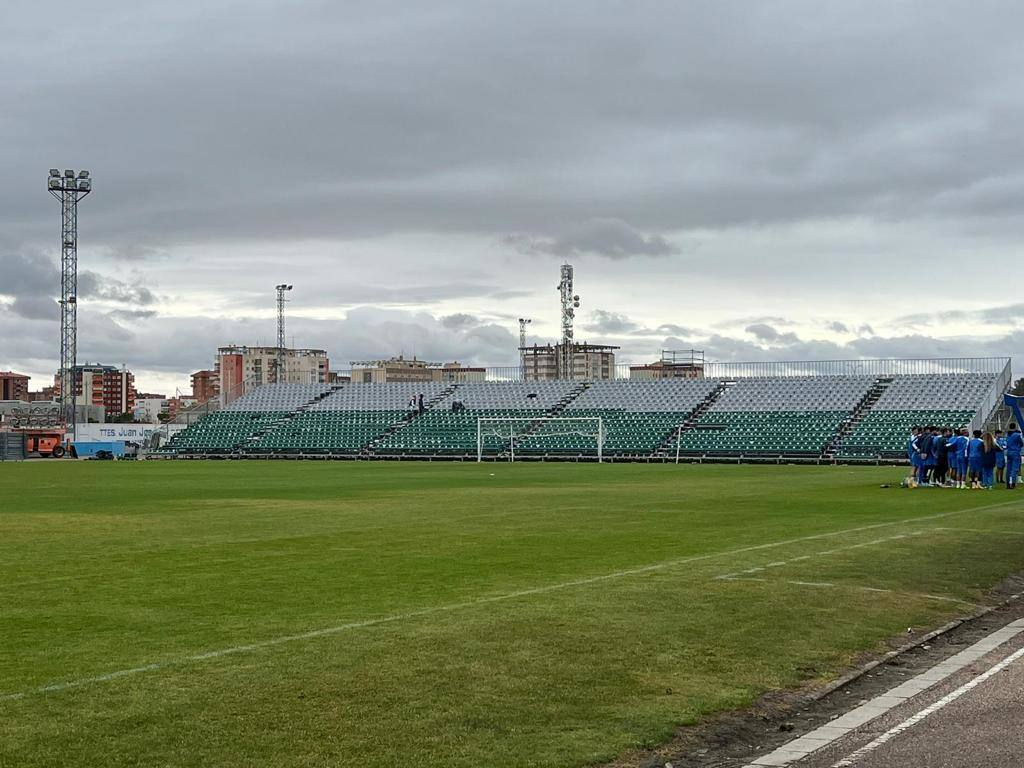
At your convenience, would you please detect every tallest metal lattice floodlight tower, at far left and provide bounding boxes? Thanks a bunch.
[46,168,92,440]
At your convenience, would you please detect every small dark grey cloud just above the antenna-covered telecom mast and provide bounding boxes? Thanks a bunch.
[502,218,679,259]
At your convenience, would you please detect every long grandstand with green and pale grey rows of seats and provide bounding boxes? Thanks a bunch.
[155,358,1011,462]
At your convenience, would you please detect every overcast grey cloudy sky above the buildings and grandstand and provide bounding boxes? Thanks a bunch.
[0,0,1024,392]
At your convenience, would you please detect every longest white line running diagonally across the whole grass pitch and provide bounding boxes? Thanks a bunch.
[0,501,1019,701]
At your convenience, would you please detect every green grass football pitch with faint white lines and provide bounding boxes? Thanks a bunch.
[6,462,1024,767]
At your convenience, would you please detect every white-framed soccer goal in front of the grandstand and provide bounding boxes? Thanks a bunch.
[476,416,604,462]
